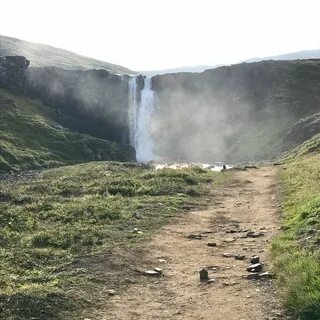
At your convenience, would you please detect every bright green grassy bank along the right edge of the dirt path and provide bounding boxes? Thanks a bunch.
[271,136,320,320]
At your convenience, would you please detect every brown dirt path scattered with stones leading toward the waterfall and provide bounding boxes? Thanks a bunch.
[103,167,282,320]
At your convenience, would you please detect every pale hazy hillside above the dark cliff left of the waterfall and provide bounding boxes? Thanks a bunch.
[0,35,135,74]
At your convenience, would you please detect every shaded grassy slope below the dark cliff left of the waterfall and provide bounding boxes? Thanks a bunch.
[0,90,132,171]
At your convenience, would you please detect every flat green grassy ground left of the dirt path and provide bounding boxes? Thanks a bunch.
[0,162,228,320]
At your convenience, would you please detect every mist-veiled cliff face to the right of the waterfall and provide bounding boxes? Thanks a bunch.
[153,60,320,162]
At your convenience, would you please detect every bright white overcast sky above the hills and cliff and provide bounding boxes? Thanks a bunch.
[0,0,320,71]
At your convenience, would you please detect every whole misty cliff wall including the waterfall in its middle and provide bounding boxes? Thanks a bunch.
[0,50,320,170]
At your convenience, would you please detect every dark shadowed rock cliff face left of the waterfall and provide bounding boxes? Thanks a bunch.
[0,57,139,144]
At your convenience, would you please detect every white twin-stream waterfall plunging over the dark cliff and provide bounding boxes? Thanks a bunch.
[129,77,155,162]
